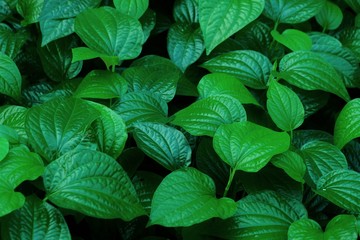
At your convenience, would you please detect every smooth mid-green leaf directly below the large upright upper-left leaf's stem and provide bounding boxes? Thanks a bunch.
[74,70,128,99]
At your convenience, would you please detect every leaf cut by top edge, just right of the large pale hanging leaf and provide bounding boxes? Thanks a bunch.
[263,0,326,24]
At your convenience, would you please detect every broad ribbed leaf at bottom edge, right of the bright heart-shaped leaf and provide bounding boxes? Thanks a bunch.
[212,191,307,240]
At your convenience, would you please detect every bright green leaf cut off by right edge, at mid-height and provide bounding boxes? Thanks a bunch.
[334,98,360,149]
